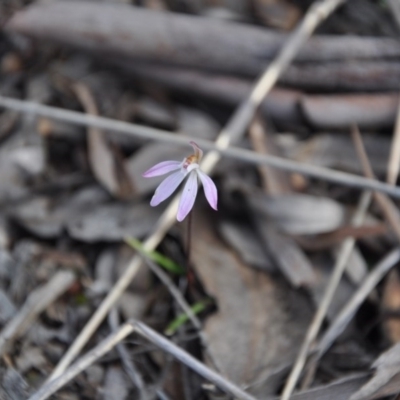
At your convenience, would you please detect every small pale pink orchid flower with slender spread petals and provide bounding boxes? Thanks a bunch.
[143,142,218,222]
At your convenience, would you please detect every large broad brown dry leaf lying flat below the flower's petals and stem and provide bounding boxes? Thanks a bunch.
[192,209,311,397]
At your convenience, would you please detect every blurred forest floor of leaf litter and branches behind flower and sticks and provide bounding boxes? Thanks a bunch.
[0,0,400,400]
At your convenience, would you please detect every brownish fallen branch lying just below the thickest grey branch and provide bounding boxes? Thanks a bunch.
[124,60,399,130]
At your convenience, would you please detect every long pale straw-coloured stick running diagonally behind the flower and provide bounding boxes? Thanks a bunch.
[46,0,346,379]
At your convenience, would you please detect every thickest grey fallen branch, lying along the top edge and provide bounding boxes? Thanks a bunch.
[6,1,400,76]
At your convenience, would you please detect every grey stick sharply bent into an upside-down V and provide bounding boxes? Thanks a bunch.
[29,321,256,400]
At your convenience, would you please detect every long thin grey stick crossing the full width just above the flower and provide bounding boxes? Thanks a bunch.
[0,96,400,198]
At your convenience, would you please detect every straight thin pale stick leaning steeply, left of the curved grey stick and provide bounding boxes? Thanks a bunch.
[281,192,372,400]
